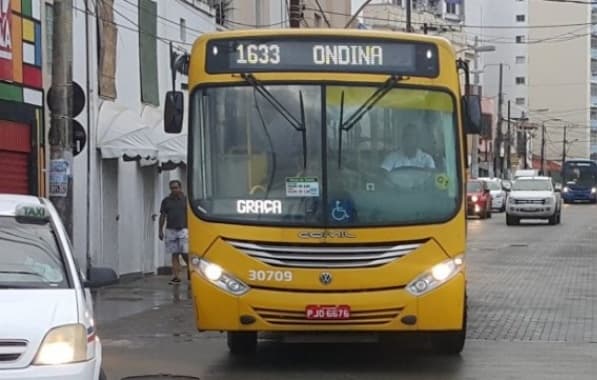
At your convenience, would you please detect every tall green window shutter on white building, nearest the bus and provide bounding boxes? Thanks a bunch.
[139,0,160,106]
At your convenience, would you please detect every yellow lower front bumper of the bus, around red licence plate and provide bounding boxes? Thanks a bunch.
[192,273,465,332]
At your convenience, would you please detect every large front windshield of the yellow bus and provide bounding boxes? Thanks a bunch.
[190,84,461,227]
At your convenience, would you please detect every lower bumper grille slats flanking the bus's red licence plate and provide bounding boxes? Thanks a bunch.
[253,307,403,325]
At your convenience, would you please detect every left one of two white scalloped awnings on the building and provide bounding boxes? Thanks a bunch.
[97,101,158,159]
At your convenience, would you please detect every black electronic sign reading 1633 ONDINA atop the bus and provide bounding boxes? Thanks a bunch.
[206,37,439,77]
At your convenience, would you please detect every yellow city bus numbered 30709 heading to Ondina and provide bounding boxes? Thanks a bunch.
[164,29,480,355]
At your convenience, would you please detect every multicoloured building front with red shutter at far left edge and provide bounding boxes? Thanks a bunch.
[0,0,46,195]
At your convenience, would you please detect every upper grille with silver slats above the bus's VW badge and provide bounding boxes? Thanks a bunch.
[227,240,422,268]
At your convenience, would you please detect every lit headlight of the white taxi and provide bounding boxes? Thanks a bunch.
[34,324,87,365]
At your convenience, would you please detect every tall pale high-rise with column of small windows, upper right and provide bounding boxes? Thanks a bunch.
[465,0,597,165]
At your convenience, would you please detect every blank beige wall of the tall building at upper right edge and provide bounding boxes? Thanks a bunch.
[529,2,591,160]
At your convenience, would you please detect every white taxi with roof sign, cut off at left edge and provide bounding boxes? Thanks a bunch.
[0,194,117,380]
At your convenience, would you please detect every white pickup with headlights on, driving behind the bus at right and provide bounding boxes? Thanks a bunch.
[506,177,562,225]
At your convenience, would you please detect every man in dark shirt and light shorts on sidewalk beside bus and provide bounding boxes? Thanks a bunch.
[159,180,189,285]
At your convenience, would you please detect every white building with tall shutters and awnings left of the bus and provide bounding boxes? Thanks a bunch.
[45,0,215,275]
